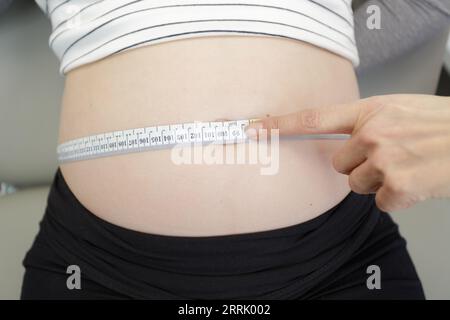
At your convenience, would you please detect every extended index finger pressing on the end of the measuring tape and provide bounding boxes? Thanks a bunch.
[246,100,362,135]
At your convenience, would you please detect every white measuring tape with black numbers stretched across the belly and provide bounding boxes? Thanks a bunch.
[56,119,347,163]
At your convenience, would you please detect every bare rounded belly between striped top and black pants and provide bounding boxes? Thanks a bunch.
[59,36,358,236]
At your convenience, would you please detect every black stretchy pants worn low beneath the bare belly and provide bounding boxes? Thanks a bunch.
[22,170,424,299]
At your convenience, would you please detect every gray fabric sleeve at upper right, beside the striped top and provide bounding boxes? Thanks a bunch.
[353,0,450,73]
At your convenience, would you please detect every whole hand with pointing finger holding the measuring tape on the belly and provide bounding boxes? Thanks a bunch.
[249,95,450,212]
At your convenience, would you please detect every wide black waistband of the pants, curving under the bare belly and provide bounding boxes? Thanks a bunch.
[33,169,380,299]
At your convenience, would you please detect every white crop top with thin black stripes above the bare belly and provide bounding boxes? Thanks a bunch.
[35,0,359,74]
